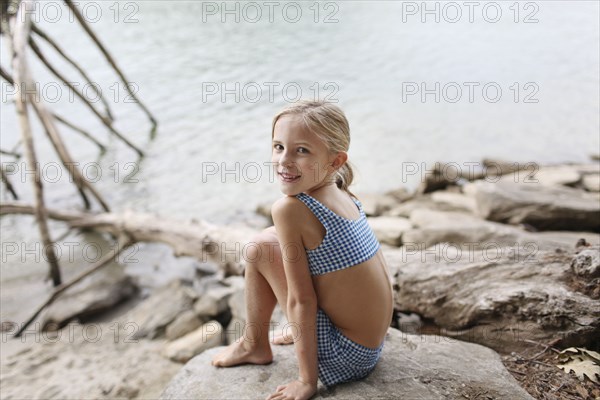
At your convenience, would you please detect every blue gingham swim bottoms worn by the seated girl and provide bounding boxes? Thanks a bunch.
[317,308,383,386]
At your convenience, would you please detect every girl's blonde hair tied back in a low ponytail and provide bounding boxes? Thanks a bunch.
[271,100,358,199]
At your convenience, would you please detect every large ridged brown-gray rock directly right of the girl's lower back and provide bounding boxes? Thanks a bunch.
[395,247,600,352]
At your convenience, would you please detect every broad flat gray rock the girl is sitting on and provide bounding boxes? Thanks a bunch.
[160,328,532,400]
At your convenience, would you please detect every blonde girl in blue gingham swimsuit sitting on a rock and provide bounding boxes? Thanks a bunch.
[212,101,393,400]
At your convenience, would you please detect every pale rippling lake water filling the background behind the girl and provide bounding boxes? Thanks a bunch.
[1,1,600,284]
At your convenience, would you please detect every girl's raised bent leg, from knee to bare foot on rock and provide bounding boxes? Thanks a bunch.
[212,227,287,367]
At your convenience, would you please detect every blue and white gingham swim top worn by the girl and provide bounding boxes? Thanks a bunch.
[295,193,379,275]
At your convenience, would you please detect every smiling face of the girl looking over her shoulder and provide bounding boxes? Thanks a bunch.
[271,115,347,196]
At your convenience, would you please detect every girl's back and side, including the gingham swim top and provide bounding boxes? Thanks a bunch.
[296,187,393,348]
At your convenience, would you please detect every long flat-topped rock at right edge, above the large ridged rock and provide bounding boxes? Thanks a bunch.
[464,181,600,232]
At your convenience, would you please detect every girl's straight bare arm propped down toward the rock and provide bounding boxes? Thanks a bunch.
[271,197,318,389]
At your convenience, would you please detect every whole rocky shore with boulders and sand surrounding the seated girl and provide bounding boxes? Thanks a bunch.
[0,160,600,399]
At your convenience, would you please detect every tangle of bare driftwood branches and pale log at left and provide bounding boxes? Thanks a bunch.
[0,0,165,336]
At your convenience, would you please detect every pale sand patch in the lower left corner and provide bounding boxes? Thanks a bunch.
[0,277,182,400]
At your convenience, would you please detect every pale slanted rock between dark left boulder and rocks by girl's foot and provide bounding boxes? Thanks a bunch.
[121,279,198,339]
